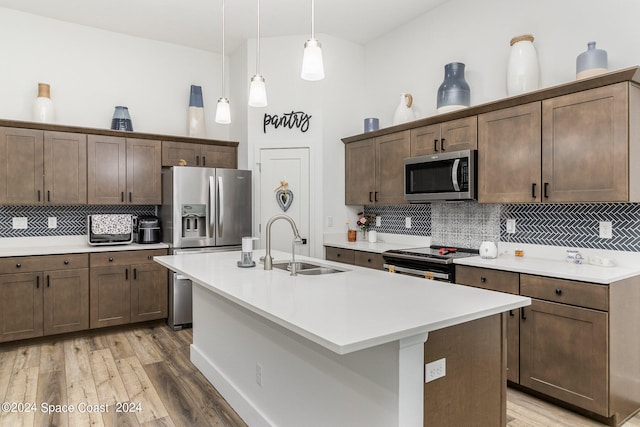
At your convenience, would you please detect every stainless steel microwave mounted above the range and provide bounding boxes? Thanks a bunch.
[404,150,478,203]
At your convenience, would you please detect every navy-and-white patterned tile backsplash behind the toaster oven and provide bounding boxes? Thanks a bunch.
[0,205,156,237]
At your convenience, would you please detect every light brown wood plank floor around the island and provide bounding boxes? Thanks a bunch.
[0,324,640,427]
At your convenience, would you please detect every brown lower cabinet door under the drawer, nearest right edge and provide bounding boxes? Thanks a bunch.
[520,299,609,415]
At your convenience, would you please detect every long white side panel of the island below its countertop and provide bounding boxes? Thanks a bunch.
[191,284,400,427]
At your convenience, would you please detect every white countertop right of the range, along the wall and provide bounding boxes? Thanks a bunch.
[454,255,640,284]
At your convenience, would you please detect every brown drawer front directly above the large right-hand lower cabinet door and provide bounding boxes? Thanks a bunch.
[520,274,609,311]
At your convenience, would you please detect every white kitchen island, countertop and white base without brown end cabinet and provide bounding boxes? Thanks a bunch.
[155,252,530,427]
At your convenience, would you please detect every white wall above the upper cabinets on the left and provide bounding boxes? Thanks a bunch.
[0,8,229,139]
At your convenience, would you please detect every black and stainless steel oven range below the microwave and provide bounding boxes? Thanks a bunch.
[382,246,479,283]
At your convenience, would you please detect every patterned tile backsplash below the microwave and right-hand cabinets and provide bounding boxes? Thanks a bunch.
[365,202,640,252]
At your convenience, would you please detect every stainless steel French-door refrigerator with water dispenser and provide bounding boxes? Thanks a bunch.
[160,166,252,329]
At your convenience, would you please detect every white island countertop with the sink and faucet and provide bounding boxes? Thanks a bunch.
[154,251,531,354]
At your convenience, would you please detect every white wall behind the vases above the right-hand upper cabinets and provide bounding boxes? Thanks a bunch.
[364,0,640,127]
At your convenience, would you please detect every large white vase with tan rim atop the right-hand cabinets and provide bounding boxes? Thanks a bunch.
[507,34,540,96]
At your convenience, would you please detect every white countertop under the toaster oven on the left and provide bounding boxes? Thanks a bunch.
[0,236,169,257]
